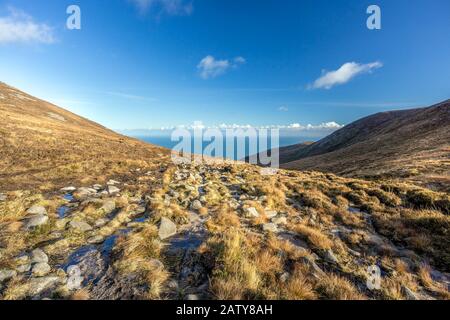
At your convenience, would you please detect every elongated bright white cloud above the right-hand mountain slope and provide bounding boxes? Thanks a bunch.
[308,61,383,89]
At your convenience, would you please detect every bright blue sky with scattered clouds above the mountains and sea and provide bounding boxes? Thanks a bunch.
[0,0,450,129]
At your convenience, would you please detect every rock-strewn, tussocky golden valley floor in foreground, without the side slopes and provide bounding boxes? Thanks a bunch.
[0,164,450,300]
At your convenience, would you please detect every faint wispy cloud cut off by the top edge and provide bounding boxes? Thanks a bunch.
[129,0,194,16]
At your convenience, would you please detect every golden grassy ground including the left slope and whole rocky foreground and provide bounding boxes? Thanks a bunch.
[0,85,450,300]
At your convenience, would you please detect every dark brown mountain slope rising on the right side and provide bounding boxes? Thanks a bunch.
[280,100,450,189]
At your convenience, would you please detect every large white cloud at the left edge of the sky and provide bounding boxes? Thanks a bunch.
[0,8,55,44]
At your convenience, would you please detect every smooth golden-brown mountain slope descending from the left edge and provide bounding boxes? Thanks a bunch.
[0,83,169,191]
